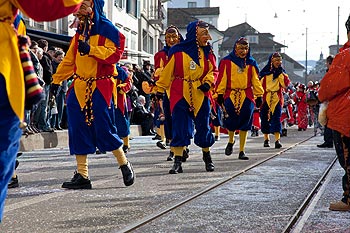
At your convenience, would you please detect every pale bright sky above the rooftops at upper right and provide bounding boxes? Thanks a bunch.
[210,0,350,61]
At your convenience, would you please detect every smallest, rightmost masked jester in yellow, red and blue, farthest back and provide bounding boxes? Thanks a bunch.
[259,52,290,148]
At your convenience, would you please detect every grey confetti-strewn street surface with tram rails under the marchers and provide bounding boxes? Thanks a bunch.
[0,128,350,233]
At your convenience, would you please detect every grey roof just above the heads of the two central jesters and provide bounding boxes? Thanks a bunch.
[168,7,220,28]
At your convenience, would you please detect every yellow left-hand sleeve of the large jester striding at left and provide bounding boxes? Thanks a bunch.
[52,37,75,84]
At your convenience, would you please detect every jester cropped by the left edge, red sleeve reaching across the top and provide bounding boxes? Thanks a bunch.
[0,0,81,221]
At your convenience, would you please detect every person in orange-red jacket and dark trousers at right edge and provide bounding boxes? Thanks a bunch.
[318,16,350,211]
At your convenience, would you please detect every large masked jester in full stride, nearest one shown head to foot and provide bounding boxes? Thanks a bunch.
[52,0,134,189]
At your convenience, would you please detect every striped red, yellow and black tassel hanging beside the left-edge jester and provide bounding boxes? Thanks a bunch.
[18,36,44,109]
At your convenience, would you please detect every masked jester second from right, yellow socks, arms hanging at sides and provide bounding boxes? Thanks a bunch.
[216,38,264,160]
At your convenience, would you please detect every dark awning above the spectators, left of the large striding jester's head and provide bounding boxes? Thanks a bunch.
[27,28,72,50]
